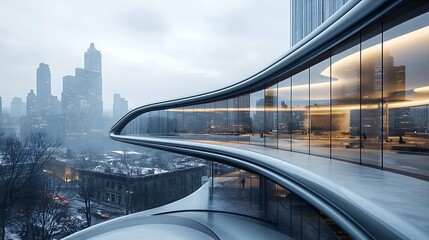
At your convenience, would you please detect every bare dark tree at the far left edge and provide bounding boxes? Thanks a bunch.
[0,133,61,240]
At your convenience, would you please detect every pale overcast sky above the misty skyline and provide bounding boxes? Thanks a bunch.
[0,0,290,111]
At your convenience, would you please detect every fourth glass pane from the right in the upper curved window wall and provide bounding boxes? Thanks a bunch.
[309,58,331,157]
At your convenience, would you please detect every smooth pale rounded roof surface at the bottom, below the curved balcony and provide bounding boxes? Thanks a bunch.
[65,184,292,240]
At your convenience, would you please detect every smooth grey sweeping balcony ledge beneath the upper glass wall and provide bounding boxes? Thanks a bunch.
[108,135,429,239]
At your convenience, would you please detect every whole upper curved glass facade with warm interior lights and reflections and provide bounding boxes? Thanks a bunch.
[121,4,429,179]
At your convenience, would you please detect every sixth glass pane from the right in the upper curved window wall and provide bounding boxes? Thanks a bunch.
[277,78,292,150]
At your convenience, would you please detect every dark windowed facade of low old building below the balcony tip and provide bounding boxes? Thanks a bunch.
[79,166,207,212]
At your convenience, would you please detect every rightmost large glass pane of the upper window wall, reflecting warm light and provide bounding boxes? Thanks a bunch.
[383,8,429,176]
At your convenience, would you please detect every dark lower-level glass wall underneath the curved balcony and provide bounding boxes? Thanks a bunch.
[209,163,350,239]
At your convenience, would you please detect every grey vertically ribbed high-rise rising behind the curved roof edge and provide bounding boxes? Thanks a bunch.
[291,0,348,46]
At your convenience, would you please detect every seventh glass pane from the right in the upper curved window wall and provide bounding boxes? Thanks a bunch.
[264,84,278,148]
